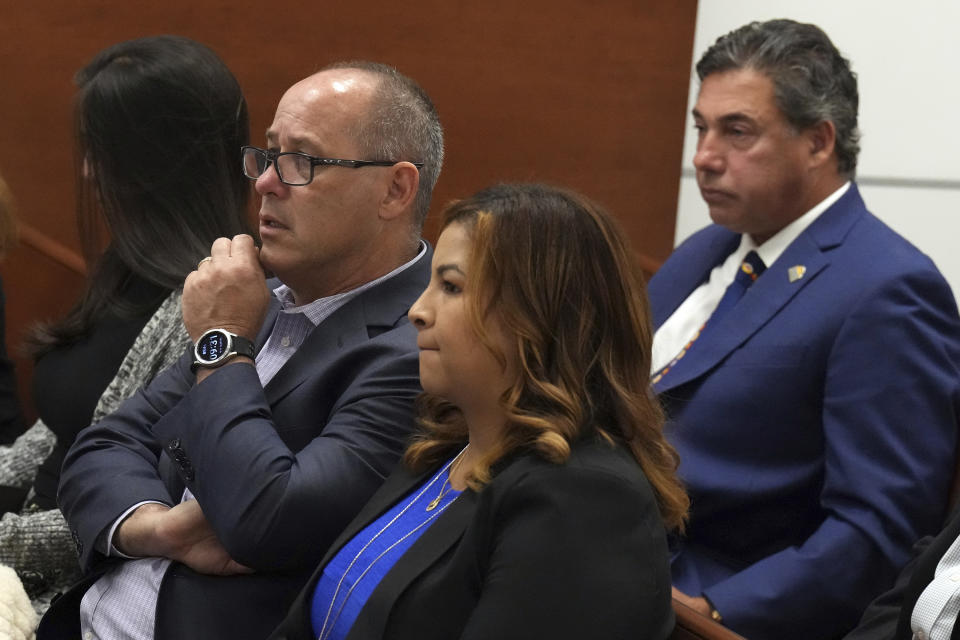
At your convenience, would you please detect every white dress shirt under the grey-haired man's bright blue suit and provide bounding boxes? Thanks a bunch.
[650,181,850,374]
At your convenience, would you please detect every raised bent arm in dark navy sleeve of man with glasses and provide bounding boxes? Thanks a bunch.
[155,336,421,570]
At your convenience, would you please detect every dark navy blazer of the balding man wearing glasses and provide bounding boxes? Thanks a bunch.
[44,250,432,640]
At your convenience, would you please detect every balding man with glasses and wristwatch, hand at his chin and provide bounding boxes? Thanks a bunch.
[38,62,443,640]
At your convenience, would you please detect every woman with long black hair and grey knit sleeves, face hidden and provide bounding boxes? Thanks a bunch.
[0,36,249,608]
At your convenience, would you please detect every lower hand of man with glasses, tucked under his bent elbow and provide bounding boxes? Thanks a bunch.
[114,500,253,575]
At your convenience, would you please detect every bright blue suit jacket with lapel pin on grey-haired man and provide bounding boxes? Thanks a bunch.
[649,185,960,640]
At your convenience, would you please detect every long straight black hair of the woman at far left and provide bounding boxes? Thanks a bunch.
[29,35,250,356]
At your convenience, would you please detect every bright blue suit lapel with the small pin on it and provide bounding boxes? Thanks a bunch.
[655,185,866,393]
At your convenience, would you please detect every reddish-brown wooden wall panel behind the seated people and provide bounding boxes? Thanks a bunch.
[0,0,696,422]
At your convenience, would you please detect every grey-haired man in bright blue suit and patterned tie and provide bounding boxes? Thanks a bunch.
[649,20,960,640]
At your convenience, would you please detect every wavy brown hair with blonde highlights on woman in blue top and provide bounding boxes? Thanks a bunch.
[405,184,689,528]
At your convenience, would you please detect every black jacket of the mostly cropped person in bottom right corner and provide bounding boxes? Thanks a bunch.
[844,509,960,640]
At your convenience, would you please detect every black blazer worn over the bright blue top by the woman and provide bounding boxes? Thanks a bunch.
[271,442,674,640]
